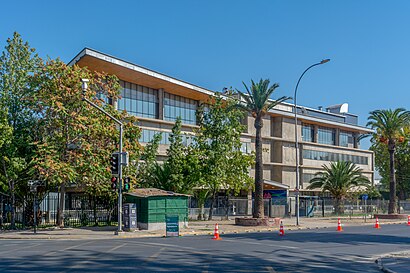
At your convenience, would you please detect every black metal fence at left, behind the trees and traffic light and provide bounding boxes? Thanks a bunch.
[0,193,118,229]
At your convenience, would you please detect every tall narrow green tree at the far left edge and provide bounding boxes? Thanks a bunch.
[0,32,42,228]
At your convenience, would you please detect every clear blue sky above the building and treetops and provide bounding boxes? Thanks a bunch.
[0,0,410,148]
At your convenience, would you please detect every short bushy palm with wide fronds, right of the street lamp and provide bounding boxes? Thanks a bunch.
[307,161,370,214]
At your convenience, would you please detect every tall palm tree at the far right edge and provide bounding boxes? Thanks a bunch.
[367,108,410,214]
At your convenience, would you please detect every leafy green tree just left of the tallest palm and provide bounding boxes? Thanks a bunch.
[194,95,254,220]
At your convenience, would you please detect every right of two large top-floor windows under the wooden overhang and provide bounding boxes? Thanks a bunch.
[164,93,198,124]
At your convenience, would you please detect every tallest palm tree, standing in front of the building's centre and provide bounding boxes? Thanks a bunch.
[238,79,290,218]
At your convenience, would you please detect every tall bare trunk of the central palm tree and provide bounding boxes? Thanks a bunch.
[253,115,264,218]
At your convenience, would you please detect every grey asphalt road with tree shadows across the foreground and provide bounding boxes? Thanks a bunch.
[0,225,410,273]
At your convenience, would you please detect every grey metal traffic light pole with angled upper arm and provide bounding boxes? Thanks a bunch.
[81,79,123,235]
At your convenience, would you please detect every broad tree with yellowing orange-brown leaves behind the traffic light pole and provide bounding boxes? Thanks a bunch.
[33,60,140,226]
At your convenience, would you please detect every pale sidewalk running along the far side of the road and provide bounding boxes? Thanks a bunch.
[0,217,405,240]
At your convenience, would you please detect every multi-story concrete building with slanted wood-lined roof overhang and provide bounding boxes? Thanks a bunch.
[70,48,374,198]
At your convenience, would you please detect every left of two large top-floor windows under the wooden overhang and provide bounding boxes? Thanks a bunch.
[118,81,158,118]
